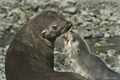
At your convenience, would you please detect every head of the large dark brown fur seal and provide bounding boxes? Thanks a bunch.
[29,10,72,41]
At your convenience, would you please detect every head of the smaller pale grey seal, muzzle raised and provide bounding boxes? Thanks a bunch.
[64,31,90,56]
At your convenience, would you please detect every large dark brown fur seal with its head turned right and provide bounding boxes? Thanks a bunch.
[5,11,85,80]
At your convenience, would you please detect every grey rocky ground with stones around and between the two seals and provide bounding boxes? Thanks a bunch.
[0,0,120,80]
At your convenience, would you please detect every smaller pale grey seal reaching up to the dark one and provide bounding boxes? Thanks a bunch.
[65,31,120,80]
